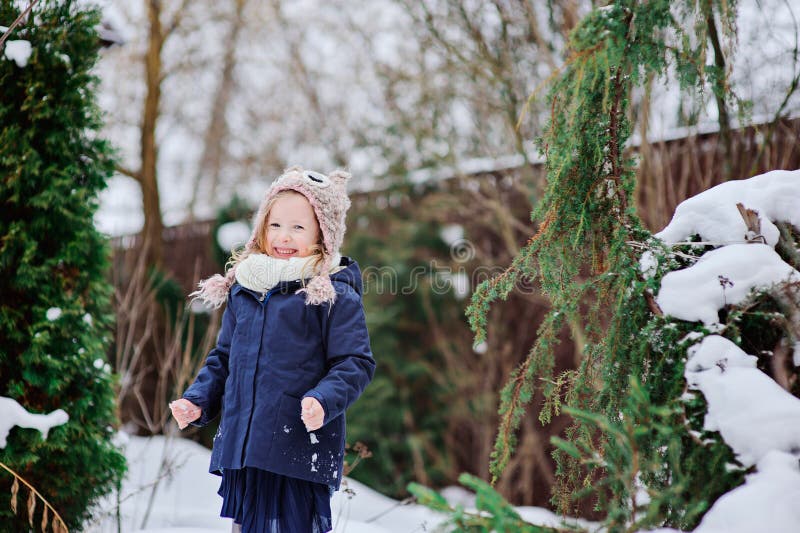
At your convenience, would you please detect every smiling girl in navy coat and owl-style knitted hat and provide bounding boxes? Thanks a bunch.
[170,167,375,533]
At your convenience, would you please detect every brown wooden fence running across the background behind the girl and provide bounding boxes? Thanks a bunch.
[112,118,800,290]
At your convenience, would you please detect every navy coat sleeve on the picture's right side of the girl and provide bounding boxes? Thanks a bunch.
[303,286,375,425]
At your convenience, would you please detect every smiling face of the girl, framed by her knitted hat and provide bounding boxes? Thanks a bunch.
[266,193,320,259]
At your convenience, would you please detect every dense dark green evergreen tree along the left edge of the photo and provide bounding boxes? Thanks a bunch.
[0,0,125,531]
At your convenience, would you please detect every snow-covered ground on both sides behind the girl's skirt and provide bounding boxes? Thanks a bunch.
[86,434,446,533]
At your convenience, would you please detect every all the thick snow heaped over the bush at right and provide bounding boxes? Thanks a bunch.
[642,170,800,533]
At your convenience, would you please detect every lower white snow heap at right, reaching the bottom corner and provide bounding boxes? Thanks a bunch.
[684,335,800,533]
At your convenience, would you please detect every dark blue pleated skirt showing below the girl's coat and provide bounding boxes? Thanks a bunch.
[218,468,333,533]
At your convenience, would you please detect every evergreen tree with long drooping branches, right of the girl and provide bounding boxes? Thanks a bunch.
[410,0,791,531]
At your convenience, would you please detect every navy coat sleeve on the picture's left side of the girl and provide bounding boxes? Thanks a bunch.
[183,294,236,427]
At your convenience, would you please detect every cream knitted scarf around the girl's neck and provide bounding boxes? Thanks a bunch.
[236,254,341,292]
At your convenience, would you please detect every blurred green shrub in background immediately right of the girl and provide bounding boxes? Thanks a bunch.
[343,185,466,497]
